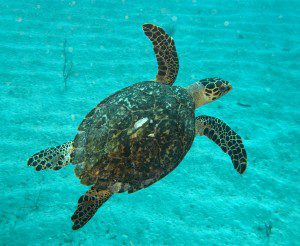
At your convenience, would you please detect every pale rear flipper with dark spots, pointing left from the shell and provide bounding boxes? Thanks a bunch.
[27,141,73,171]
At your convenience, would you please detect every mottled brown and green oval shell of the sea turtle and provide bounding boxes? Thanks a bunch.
[71,81,195,193]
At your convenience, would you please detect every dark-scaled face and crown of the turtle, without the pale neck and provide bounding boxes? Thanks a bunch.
[197,78,232,102]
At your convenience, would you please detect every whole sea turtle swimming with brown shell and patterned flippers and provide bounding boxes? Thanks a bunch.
[27,24,247,230]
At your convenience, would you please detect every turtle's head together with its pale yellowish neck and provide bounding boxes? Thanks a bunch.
[187,78,232,108]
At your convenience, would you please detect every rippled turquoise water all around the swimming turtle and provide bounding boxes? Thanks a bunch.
[0,0,300,245]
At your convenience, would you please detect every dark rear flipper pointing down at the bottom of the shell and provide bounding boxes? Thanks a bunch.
[71,186,112,230]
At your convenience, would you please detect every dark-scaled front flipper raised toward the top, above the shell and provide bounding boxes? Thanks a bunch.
[143,24,179,85]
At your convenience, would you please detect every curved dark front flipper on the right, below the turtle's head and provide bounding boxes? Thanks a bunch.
[196,116,247,174]
